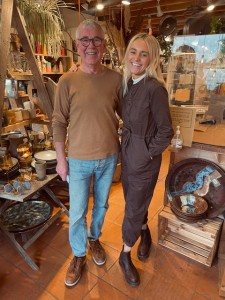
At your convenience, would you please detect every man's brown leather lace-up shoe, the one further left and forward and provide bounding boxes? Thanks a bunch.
[64,256,86,286]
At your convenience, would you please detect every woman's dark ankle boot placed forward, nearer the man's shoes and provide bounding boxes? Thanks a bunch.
[119,251,140,286]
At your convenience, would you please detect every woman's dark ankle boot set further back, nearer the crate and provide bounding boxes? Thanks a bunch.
[137,227,152,260]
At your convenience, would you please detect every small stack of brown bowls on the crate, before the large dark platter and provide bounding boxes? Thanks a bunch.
[170,194,208,223]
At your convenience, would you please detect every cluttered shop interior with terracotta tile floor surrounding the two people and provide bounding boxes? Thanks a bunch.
[0,0,225,300]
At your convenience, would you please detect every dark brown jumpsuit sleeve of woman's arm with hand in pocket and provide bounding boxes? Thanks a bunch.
[148,86,173,157]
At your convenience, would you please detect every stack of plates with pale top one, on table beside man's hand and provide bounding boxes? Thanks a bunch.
[31,150,57,174]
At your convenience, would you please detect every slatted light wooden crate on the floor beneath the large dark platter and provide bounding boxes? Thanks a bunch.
[158,204,223,267]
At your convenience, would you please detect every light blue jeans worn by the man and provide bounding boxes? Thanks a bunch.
[69,154,118,257]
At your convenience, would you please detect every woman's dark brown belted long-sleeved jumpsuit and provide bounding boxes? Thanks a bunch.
[121,77,173,247]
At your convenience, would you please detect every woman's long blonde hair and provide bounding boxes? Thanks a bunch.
[123,33,165,94]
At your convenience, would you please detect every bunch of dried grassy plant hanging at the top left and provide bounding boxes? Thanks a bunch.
[18,0,66,52]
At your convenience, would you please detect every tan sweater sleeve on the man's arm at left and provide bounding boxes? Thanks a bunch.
[52,76,70,142]
